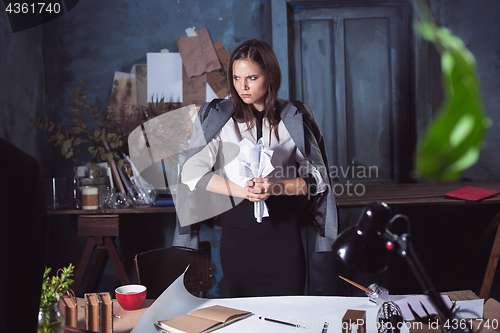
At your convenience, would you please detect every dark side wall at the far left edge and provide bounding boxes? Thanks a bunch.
[0,11,50,167]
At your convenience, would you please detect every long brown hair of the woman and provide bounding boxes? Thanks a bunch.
[227,39,281,142]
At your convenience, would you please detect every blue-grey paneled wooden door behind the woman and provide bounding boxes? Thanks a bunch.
[289,1,415,184]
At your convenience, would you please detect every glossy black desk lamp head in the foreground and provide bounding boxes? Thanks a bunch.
[332,201,391,273]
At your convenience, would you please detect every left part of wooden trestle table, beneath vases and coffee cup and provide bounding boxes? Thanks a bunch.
[47,207,175,294]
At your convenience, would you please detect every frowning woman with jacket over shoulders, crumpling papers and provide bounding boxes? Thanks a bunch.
[178,40,337,297]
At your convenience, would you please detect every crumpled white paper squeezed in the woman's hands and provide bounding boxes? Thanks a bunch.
[238,138,274,223]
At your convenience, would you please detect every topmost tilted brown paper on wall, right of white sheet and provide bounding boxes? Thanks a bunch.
[175,28,221,77]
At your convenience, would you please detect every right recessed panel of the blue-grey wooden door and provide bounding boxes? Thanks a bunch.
[344,17,394,180]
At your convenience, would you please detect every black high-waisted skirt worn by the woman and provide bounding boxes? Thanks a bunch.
[220,196,306,297]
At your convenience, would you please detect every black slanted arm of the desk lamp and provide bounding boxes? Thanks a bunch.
[386,231,454,321]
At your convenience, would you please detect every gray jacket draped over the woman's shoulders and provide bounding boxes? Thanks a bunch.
[173,99,338,252]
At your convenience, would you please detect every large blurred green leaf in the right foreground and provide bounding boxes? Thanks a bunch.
[415,13,491,181]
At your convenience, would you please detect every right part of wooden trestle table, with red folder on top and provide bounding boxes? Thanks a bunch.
[336,182,500,299]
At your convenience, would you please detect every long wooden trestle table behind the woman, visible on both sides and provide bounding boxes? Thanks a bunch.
[48,182,500,299]
